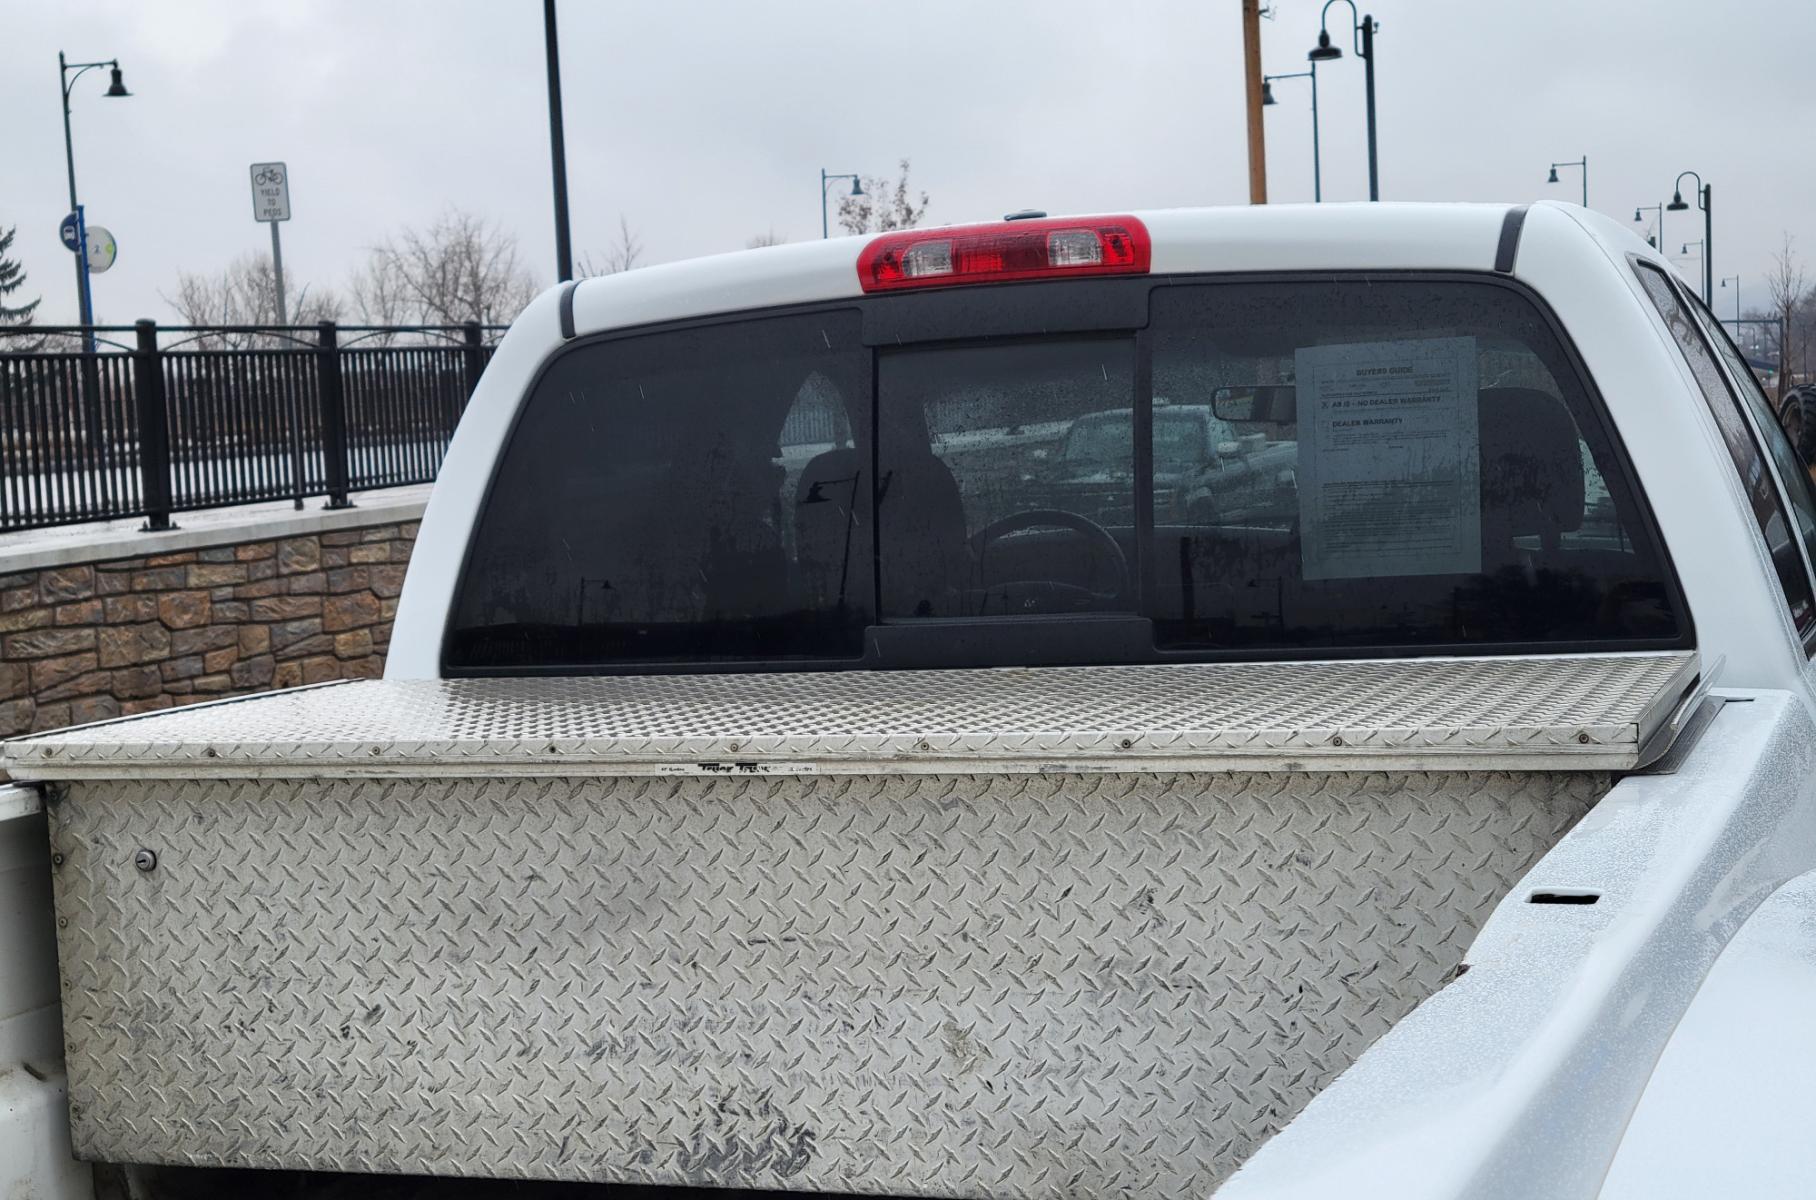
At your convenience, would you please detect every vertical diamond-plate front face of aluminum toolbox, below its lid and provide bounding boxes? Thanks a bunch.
[51,772,1609,1200]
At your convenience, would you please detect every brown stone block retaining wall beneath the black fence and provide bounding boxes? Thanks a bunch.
[0,521,416,737]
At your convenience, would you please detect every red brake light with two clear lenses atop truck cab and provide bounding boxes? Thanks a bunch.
[857,216,1153,292]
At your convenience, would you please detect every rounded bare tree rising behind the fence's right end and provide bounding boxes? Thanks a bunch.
[354,209,538,325]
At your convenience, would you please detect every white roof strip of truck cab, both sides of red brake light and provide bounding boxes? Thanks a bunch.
[572,202,1663,336]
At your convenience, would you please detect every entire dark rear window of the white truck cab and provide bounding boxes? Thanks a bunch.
[443,276,1689,674]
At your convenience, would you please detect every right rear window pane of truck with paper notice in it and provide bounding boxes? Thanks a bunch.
[1150,281,1680,650]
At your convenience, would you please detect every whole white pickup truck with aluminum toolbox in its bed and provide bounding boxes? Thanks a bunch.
[0,205,1816,1200]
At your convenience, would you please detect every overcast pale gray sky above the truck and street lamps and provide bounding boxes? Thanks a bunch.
[10,0,1816,323]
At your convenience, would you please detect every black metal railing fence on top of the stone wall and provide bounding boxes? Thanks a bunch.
[0,321,503,530]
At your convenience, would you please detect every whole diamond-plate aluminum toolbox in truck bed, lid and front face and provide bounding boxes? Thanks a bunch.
[5,654,1696,1196]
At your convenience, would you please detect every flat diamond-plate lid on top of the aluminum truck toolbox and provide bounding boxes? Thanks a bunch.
[4,652,1696,779]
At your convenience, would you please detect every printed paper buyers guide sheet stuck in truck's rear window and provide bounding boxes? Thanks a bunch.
[1295,338,1482,579]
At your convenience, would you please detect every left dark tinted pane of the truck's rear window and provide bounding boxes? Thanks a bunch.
[447,312,875,666]
